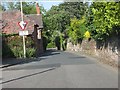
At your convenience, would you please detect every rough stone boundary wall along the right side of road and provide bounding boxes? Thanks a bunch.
[67,36,120,67]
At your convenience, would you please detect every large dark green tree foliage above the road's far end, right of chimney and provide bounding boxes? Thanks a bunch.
[43,2,86,46]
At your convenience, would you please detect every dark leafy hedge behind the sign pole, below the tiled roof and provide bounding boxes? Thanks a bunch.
[2,35,35,58]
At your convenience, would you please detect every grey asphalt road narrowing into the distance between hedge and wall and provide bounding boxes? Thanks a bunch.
[2,51,118,88]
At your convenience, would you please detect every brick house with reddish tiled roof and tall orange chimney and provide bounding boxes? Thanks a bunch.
[0,4,43,56]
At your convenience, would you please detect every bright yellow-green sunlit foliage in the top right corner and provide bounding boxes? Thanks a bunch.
[91,2,120,40]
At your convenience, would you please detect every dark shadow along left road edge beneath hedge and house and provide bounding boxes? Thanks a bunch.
[2,49,60,68]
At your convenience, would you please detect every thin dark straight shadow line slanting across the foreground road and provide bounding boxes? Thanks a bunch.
[0,68,56,84]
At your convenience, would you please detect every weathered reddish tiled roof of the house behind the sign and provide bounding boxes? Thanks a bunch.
[0,10,43,34]
